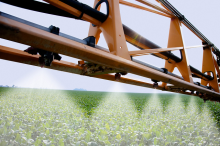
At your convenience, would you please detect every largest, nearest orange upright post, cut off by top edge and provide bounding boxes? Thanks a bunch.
[89,0,131,60]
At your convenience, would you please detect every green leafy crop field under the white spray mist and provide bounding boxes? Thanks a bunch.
[0,88,220,146]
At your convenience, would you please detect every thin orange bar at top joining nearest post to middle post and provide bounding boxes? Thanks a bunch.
[119,0,173,18]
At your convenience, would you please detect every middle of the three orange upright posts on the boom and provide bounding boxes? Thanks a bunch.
[162,18,193,86]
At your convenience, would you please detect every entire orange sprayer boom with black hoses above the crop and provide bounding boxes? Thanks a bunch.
[0,0,220,101]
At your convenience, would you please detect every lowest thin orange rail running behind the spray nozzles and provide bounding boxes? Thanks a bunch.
[0,46,166,90]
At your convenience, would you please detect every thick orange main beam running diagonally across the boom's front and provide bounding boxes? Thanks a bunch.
[0,16,220,99]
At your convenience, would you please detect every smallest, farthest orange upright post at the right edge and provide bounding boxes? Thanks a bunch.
[201,47,219,92]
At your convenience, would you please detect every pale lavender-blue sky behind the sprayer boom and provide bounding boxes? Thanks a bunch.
[0,0,220,93]
